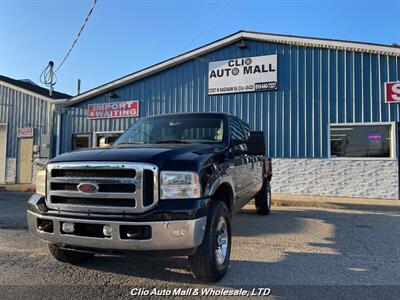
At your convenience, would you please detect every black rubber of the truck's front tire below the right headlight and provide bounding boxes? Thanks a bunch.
[189,201,231,282]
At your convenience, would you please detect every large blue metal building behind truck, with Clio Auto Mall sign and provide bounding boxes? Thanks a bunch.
[58,31,400,199]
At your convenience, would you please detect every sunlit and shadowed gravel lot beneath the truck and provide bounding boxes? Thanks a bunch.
[0,192,400,299]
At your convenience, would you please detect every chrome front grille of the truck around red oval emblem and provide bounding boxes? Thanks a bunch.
[46,162,158,213]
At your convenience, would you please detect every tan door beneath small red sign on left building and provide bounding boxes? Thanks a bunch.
[18,138,33,183]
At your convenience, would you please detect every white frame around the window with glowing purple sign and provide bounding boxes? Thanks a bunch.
[328,122,398,160]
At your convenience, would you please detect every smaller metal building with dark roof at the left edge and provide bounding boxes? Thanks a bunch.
[0,75,71,183]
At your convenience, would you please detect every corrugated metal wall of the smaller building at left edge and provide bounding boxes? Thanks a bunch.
[0,83,49,158]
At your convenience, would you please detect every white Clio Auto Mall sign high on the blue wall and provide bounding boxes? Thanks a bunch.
[208,54,278,95]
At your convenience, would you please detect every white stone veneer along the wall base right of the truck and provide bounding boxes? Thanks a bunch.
[271,158,399,199]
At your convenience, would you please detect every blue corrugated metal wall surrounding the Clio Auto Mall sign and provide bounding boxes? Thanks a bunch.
[62,41,400,158]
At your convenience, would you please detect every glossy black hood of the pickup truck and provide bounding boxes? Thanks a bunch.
[50,144,219,171]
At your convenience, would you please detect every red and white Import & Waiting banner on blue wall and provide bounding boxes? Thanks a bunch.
[88,100,139,119]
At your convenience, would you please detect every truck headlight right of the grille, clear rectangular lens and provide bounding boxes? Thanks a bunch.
[160,171,200,199]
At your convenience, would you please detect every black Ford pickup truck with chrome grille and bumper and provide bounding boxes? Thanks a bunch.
[27,113,272,281]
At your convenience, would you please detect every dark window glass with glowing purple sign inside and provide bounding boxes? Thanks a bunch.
[330,125,394,158]
